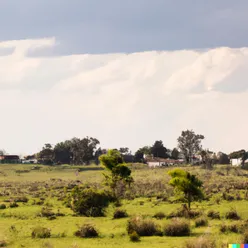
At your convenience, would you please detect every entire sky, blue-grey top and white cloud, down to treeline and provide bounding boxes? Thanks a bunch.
[0,0,248,154]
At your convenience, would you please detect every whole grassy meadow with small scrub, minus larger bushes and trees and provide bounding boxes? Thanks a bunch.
[0,164,248,248]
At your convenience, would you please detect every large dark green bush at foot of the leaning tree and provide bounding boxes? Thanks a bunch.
[69,187,114,217]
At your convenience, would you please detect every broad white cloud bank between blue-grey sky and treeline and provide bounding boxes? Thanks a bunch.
[0,39,248,152]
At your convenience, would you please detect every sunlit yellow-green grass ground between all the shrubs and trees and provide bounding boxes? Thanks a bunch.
[0,165,248,248]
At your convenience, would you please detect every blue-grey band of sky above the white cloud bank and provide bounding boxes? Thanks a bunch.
[0,0,248,54]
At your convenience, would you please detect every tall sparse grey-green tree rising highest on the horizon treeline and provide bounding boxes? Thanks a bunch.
[177,130,204,163]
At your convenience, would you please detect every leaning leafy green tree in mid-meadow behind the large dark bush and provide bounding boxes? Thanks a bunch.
[99,150,133,197]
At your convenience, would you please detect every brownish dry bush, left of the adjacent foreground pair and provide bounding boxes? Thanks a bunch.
[127,217,161,236]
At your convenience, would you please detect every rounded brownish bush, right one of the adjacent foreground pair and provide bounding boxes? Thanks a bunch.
[164,219,190,237]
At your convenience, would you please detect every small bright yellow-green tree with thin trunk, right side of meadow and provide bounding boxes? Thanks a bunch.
[168,169,204,209]
